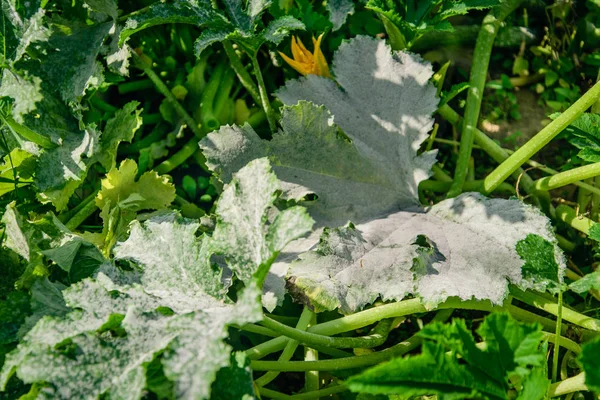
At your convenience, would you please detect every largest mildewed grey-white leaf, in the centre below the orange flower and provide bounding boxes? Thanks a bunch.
[201,37,564,313]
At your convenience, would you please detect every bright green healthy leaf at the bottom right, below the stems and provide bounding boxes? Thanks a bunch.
[346,314,549,400]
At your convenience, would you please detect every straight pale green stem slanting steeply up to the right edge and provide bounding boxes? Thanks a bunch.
[485,78,600,193]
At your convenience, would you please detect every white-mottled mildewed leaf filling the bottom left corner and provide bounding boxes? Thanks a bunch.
[0,159,311,399]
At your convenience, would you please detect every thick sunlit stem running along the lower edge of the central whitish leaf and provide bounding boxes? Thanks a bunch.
[246,298,502,360]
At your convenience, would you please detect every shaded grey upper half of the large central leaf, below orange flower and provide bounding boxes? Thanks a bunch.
[201,37,437,226]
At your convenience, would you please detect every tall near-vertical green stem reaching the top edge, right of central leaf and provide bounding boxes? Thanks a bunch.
[448,0,522,197]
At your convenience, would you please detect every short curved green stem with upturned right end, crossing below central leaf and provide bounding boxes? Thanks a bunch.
[261,316,391,349]
